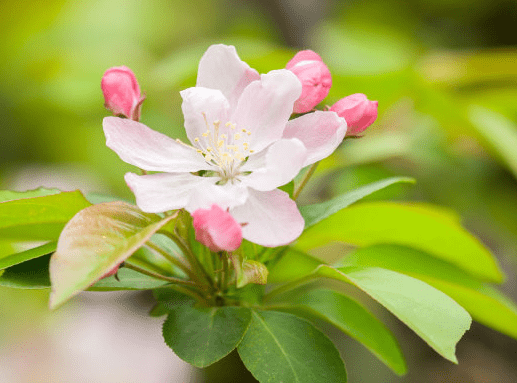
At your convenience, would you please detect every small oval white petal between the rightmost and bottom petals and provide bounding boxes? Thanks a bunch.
[241,138,307,191]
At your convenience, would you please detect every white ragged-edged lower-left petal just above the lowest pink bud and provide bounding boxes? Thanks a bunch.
[124,173,248,213]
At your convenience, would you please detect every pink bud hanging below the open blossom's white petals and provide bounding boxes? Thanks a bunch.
[192,204,242,251]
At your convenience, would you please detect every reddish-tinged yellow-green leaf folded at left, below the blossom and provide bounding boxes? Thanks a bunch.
[50,202,173,308]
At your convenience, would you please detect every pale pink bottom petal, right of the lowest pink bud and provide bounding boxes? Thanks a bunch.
[230,189,305,247]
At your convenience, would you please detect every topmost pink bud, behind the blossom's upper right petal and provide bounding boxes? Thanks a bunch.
[285,50,332,113]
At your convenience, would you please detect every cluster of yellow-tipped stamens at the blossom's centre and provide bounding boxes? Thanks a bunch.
[178,113,253,184]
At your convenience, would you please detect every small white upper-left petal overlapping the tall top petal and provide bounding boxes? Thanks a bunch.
[180,87,230,144]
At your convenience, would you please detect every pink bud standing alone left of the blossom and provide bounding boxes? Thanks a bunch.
[101,66,145,121]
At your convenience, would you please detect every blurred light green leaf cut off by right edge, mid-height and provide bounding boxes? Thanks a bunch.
[469,105,517,178]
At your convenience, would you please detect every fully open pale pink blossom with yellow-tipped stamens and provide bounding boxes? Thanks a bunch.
[103,45,346,247]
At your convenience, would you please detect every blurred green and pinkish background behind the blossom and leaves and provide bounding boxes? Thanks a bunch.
[0,0,517,383]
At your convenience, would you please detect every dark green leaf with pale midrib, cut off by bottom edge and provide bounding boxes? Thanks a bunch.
[237,311,347,383]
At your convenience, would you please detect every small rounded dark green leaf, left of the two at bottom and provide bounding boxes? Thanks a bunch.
[163,305,251,367]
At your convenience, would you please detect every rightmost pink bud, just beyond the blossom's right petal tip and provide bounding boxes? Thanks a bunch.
[330,93,379,136]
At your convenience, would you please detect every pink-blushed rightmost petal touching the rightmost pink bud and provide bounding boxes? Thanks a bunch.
[284,110,347,167]
